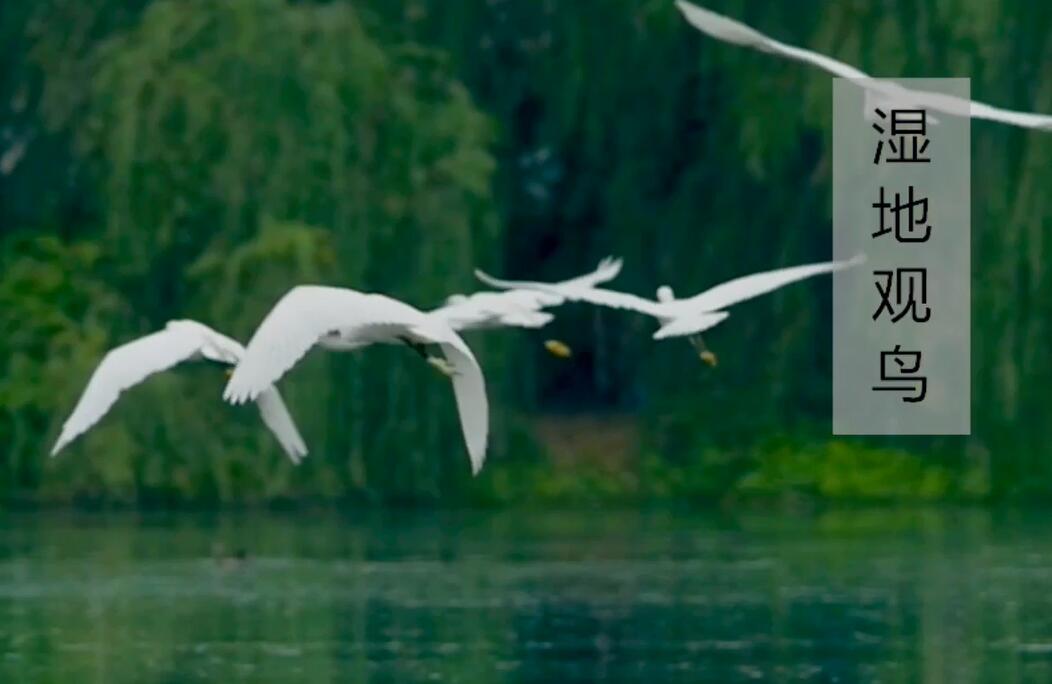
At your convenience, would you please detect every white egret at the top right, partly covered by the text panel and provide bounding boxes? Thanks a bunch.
[675,0,1052,130]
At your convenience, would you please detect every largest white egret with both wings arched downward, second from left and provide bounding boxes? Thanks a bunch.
[223,285,489,474]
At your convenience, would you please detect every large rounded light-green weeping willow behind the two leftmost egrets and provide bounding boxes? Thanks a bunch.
[0,0,501,499]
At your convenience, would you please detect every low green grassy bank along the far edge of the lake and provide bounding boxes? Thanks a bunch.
[2,438,1001,509]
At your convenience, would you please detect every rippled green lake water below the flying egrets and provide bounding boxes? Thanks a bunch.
[0,510,1052,684]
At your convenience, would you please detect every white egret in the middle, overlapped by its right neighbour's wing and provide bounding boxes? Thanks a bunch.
[428,252,622,358]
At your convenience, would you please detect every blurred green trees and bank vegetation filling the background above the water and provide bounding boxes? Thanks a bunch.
[0,0,1052,505]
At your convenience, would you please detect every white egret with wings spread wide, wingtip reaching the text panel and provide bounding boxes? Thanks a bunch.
[474,256,863,365]
